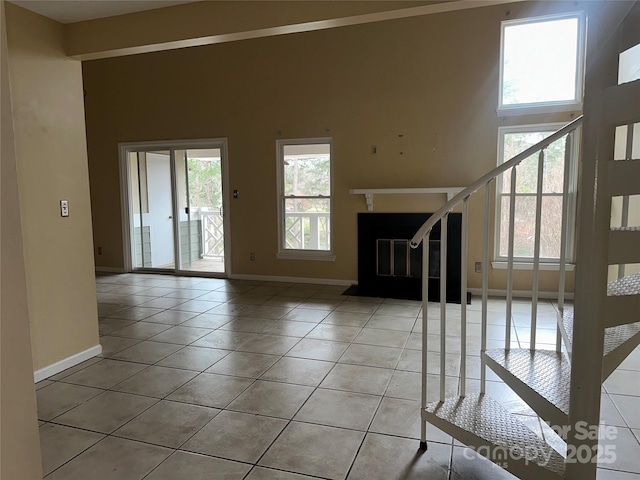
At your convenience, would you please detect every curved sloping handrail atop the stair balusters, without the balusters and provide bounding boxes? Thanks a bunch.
[410,115,582,248]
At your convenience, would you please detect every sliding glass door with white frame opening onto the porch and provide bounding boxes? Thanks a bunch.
[120,140,229,276]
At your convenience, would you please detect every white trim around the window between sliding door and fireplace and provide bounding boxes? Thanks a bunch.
[276,137,336,262]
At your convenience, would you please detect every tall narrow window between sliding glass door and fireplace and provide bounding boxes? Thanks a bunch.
[276,138,335,260]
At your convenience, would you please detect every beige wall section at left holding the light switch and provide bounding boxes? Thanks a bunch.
[6,4,99,370]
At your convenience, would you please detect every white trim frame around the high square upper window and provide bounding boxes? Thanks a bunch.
[496,12,586,117]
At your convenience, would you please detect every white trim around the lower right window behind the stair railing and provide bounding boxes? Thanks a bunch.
[492,122,581,262]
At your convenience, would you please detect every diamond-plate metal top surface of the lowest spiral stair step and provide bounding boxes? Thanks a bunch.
[425,393,565,477]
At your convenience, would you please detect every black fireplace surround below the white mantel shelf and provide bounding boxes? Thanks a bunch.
[351,213,462,303]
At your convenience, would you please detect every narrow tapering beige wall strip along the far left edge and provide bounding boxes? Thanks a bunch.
[0,1,42,480]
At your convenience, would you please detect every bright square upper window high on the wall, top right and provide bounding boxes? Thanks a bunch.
[499,13,584,114]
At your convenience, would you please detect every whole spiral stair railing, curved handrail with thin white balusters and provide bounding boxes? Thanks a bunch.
[410,116,583,449]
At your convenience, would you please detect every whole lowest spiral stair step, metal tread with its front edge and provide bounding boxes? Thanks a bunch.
[423,393,565,480]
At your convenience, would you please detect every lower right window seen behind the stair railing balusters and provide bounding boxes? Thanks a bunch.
[495,124,578,263]
